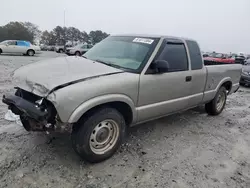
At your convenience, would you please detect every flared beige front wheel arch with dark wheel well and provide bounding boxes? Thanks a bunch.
[68,94,137,125]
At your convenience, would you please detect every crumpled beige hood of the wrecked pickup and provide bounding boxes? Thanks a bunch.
[14,57,122,96]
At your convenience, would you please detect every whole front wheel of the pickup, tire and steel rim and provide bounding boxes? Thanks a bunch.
[71,107,126,163]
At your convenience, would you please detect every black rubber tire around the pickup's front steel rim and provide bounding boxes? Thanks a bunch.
[71,107,126,163]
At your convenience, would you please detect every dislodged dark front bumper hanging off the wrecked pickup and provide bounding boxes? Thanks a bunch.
[2,95,48,121]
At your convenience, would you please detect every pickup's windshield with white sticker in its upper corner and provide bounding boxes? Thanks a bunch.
[84,36,158,71]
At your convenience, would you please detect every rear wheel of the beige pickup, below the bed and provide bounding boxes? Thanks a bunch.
[205,86,227,116]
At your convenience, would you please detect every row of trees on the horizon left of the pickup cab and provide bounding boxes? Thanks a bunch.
[0,22,109,45]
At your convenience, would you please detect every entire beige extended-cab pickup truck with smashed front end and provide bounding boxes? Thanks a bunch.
[2,35,242,162]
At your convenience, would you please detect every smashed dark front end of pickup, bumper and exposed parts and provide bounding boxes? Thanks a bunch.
[2,88,71,132]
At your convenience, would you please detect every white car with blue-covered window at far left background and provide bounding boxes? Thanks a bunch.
[0,40,41,56]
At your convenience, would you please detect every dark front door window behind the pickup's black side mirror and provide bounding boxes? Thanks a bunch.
[158,43,188,72]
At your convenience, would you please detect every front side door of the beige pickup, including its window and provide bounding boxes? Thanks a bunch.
[137,40,192,122]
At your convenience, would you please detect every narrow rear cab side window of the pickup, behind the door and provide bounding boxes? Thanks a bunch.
[186,40,203,70]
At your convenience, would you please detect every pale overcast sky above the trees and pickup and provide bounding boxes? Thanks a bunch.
[0,0,250,54]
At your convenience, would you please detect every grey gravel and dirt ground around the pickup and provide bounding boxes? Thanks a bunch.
[0,52,250,188]
